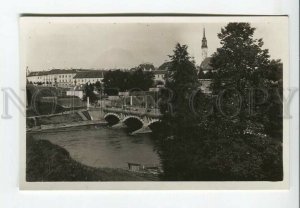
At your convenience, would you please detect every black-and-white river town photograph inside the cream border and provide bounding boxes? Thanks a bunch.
[20,16,288,183]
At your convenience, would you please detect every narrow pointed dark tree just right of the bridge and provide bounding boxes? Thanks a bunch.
[157,44,202,180]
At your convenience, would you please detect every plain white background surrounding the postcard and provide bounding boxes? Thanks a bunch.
[0,0,299,208]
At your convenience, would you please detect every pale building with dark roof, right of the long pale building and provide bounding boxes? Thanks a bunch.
[73,70,104,85]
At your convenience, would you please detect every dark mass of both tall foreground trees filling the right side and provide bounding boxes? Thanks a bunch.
[158,23,283,181]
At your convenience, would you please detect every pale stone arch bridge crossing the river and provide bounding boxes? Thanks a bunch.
[103,108,161,134]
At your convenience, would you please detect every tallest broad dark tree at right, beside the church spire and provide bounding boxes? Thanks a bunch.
[208,23,283,180]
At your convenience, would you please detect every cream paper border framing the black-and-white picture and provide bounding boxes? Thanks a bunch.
[20,16,289,190]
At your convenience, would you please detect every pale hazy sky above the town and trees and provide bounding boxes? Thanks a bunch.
[21,19,286,71]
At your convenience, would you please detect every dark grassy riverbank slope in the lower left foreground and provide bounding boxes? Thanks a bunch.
[26,135,158,182]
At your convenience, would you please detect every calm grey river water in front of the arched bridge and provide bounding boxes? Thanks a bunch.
[32,125,160,168]
